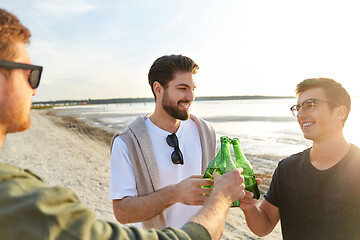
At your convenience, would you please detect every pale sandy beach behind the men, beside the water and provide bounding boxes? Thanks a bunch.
[0,109,281,240]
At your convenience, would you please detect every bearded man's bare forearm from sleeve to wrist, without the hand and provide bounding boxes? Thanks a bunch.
[113,186,176,224]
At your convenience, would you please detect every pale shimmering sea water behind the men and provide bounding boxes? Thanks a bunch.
[57,97,360,173]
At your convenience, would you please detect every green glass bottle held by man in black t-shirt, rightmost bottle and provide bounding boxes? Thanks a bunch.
[232,138,260,199]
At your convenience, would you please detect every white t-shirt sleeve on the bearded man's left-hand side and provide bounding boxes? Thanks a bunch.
[109,136,137,199]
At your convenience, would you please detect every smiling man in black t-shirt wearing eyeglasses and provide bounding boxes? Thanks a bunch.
[240,78,360,240]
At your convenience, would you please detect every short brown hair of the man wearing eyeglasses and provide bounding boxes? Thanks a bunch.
[295,78,351,124]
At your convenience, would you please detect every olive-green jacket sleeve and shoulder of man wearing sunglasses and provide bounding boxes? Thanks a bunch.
[0,164,210,240]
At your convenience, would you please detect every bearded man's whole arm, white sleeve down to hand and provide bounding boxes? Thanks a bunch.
[109,137,212,224]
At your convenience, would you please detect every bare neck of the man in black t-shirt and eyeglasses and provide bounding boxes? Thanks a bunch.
[310,135,350,170]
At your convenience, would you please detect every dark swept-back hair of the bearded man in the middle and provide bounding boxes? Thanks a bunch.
[148,55,199,97]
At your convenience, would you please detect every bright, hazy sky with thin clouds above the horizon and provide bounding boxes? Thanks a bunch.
[0,0,360,101]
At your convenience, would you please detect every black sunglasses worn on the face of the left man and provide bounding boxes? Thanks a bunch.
[0,61,42,89]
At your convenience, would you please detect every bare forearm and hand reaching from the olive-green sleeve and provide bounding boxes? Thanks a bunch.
[190,168,245,239]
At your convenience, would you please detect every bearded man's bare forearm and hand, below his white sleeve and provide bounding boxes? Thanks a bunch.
[113,175,213,224]
